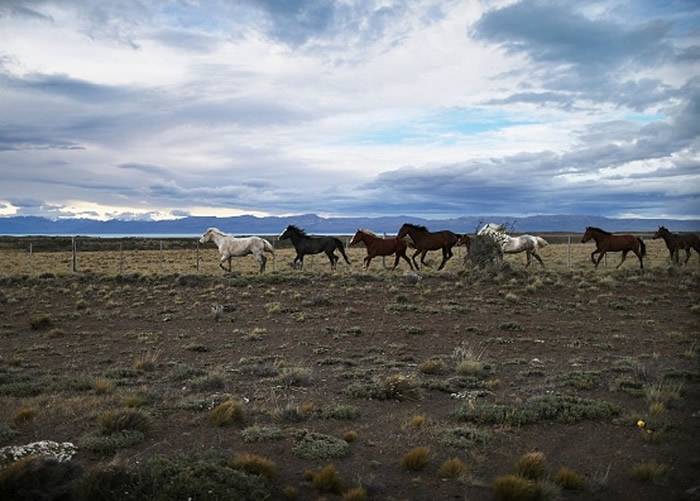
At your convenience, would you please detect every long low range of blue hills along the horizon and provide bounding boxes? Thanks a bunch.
[0,214,700,235]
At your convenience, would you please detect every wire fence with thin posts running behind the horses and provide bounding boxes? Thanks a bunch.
[0,234,684,276]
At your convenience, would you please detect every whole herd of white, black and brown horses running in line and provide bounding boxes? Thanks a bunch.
[199,223,700,273]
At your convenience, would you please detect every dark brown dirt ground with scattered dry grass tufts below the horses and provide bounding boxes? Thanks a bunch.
[0,243,700,500]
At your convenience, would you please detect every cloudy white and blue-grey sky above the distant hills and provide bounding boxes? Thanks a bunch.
[0,0,700,219]
